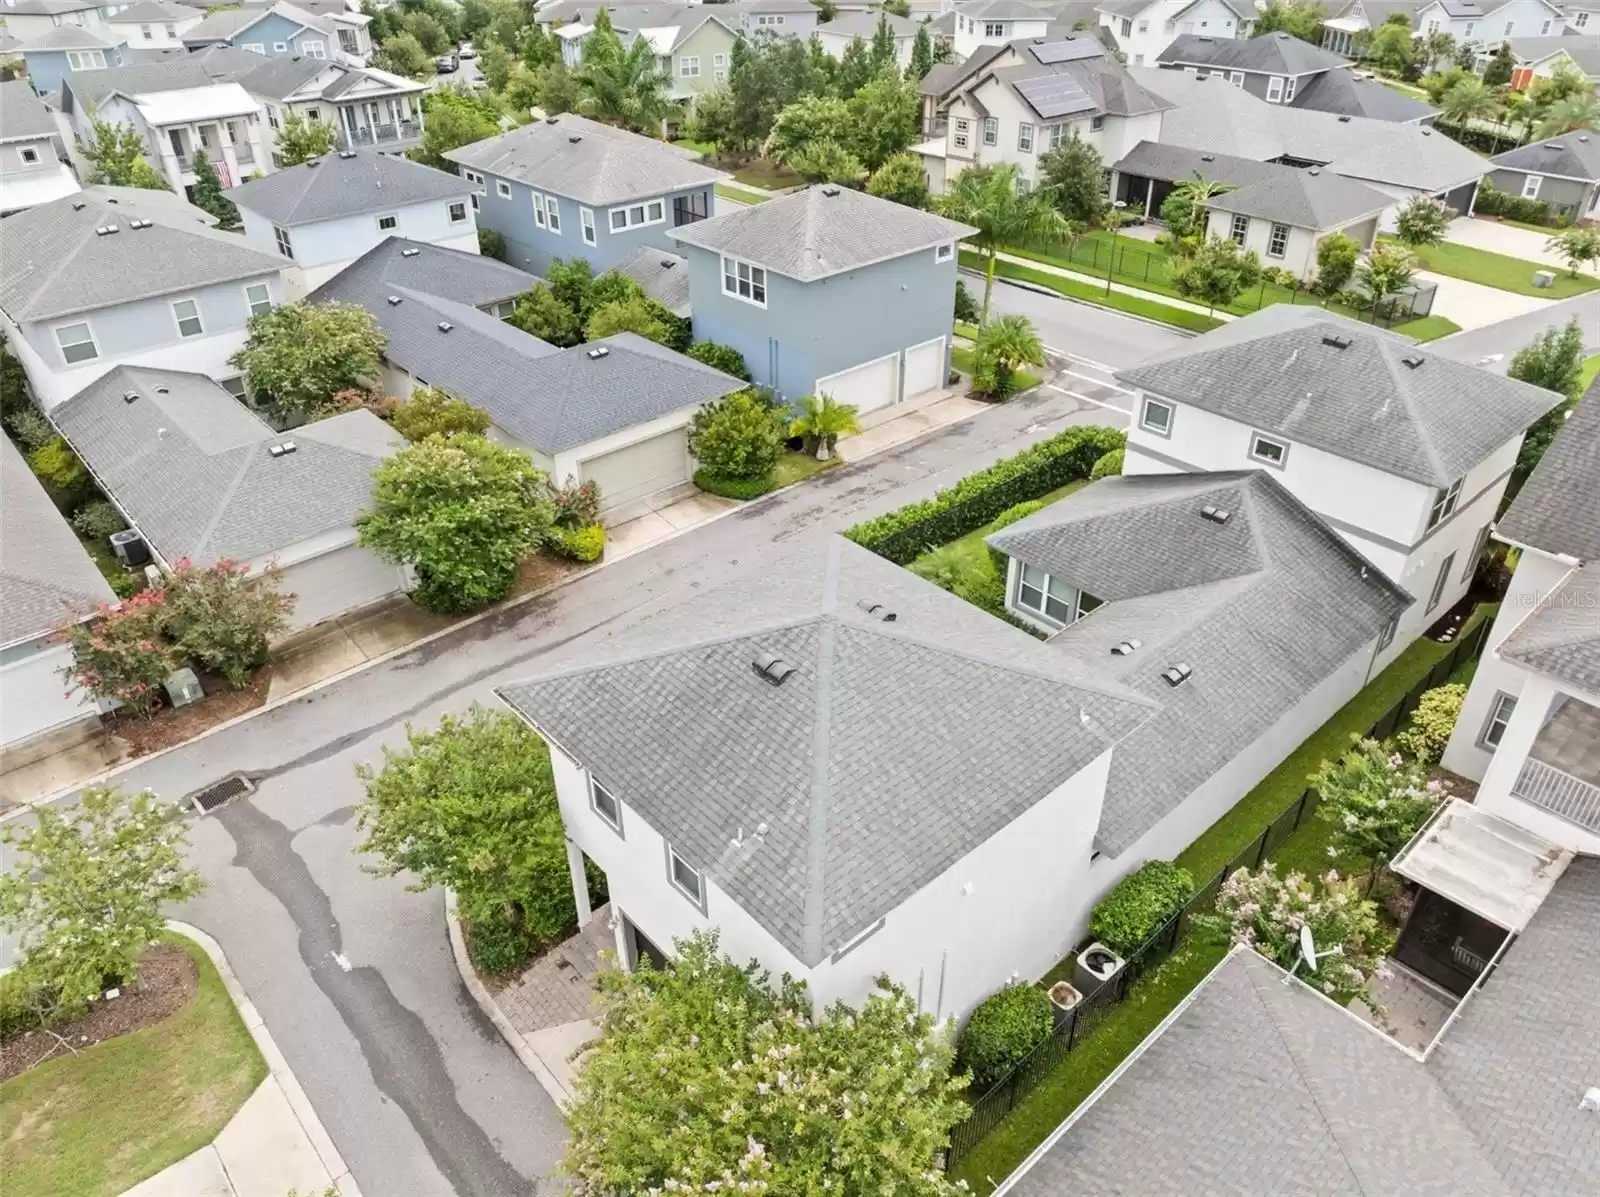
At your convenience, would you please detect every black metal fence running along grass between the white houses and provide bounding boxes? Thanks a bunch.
[946,619,1490,1168]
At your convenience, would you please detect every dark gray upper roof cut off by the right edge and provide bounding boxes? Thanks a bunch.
[1496,382,1600,562]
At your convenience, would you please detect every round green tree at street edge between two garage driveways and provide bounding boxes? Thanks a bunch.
[360,434,554,611]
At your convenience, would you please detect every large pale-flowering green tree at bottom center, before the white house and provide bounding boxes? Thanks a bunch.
[566,931,966,1197]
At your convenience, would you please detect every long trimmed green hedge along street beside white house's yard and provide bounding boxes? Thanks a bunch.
[844,424,1125,565]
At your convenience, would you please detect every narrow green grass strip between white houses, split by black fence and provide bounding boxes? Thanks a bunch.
[940,601,1498,1194]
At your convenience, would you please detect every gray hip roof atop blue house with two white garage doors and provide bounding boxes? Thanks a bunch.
[667,186,978,283]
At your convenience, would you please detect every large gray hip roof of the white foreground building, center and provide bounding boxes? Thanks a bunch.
[499,538,1147,965]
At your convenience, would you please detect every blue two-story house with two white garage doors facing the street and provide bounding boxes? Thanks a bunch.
[672,184,978,413]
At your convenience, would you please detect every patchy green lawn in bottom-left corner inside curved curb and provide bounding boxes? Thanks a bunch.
[0,936,267,1197]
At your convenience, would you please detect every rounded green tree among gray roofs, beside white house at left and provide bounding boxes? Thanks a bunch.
[227,302,387,421]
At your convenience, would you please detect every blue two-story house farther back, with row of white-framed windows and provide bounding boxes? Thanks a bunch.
[445,114,726,275]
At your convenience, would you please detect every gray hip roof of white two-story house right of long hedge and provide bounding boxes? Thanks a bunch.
[1117,304,1562,486]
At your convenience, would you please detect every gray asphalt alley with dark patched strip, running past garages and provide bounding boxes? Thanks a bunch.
[25,324,1152,1197]
